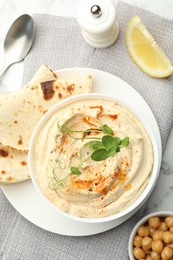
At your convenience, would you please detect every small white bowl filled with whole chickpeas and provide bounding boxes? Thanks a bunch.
[128,211,173,260]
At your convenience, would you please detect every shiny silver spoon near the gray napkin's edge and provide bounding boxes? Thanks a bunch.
[0,14,34,78]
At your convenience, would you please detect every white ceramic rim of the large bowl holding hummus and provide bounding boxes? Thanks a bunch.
[28,93,161,223]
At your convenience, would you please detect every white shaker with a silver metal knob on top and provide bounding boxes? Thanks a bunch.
[77,0,119,48]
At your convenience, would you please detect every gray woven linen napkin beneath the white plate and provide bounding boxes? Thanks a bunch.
[0,2,173,260]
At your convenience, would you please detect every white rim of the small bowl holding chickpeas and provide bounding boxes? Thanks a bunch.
[128,211,173,260]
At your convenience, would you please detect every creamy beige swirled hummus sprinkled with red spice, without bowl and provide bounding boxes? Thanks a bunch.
[34,100,153,218]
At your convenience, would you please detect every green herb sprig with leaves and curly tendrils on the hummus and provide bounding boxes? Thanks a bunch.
[49,124,129,191]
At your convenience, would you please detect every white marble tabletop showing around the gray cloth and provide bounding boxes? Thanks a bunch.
[0,0,173,215]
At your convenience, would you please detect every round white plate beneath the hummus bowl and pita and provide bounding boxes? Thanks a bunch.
[2,68,162,236]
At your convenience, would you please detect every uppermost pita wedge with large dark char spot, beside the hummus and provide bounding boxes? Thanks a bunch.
[0,67,92,152]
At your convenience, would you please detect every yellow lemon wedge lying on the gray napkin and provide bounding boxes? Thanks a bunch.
[126,16,173,78]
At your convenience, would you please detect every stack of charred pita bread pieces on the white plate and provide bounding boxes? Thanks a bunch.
[0,65,92,184]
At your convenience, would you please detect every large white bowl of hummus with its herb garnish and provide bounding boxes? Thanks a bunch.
[28,93,160,225]
